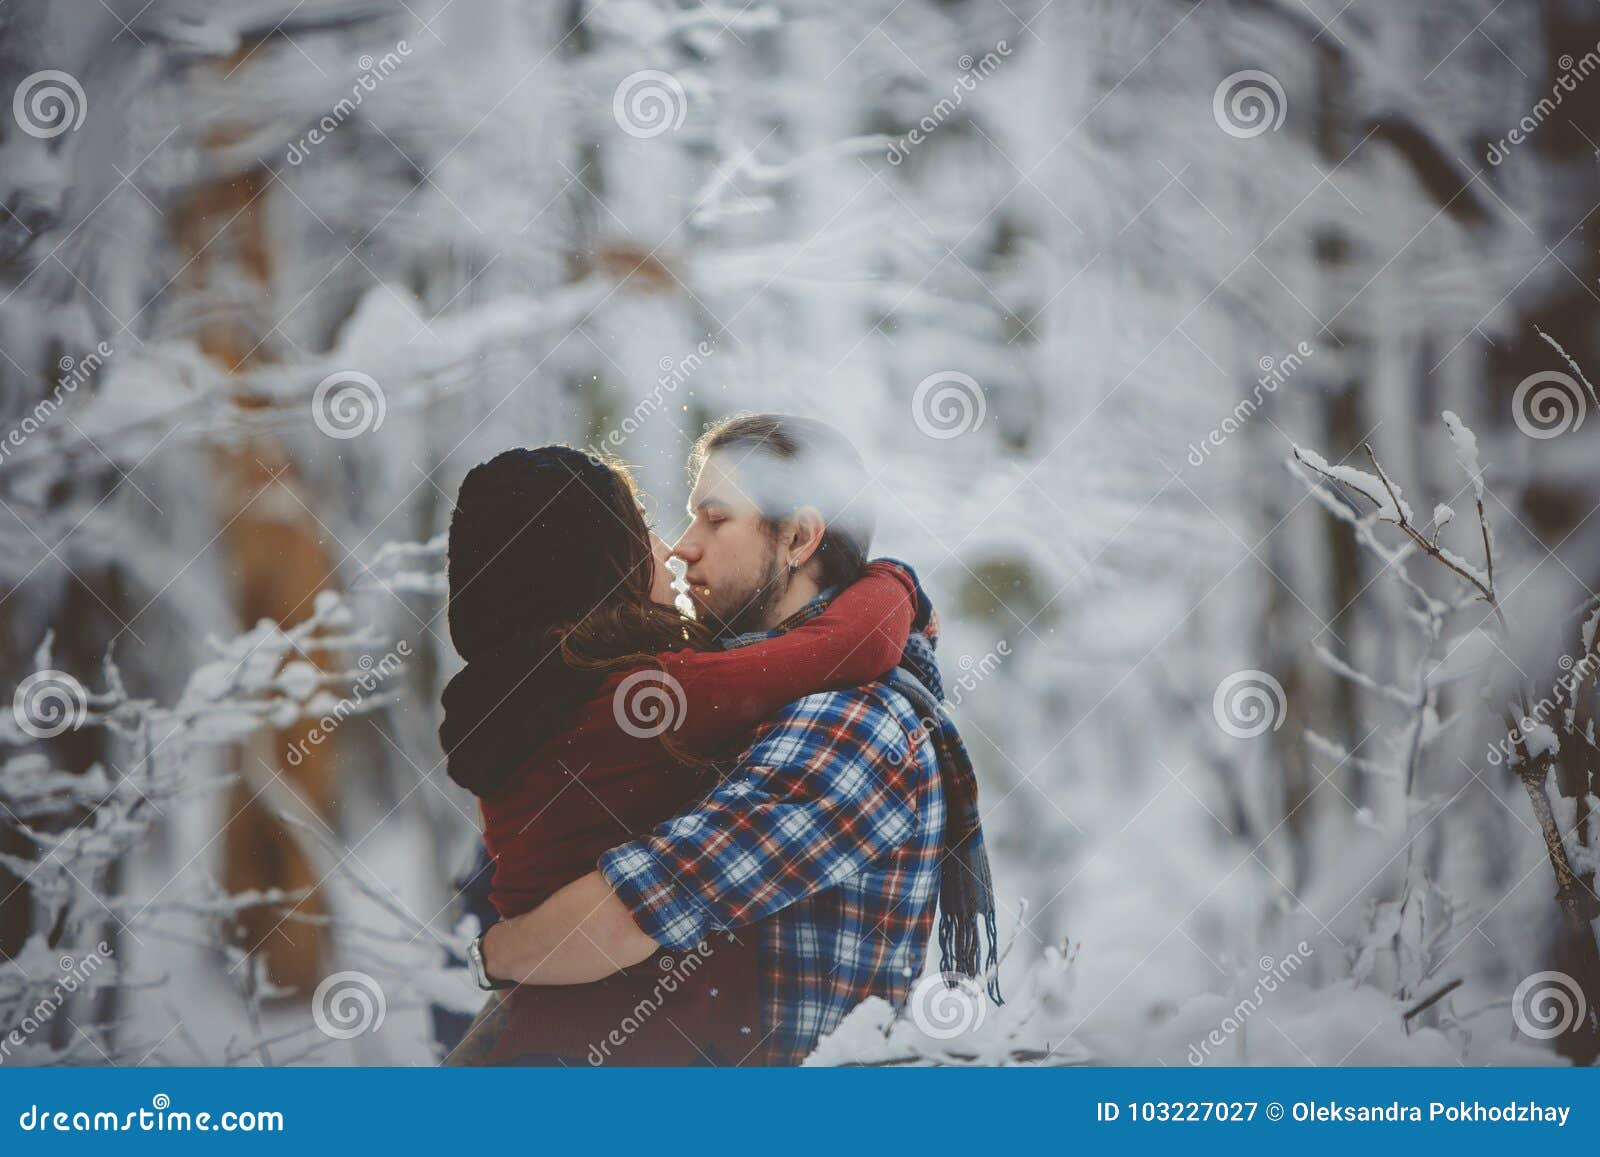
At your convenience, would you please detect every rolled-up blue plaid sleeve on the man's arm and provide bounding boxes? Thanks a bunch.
[598,688,918,949]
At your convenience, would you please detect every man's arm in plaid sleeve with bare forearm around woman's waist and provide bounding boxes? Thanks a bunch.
[483,691,938,984]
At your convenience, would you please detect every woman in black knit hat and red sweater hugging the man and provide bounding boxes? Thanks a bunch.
[440,446,914,1064]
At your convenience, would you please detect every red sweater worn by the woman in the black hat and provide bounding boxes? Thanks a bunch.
[482,563,915,1064]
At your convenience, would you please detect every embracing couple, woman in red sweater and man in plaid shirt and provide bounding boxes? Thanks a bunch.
[440,414,1000,1066]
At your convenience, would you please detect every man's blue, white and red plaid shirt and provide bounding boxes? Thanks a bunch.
[600,600,944,1064]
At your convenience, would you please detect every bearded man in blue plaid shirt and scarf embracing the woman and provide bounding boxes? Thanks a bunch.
[480,414,998,1064]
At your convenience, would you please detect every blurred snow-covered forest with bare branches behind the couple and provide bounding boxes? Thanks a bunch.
[0,0,1600,1064]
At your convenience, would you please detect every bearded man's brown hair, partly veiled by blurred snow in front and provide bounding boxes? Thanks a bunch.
[690,414,877,587]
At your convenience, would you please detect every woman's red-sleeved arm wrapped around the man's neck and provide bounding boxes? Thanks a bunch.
[661,562,917,747]
